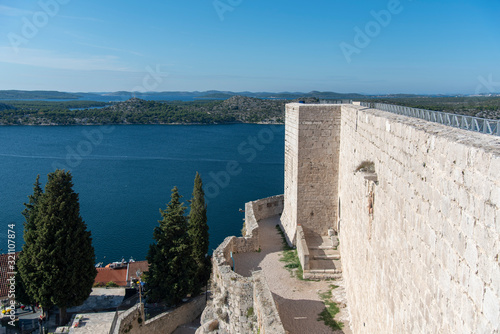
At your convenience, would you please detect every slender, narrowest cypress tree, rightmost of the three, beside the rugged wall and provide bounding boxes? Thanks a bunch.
[188,172,211,296]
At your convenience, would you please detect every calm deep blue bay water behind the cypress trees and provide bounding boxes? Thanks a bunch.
[0,124,284,263]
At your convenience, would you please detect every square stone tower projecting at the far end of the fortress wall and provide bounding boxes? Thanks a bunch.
[281,103,341,244]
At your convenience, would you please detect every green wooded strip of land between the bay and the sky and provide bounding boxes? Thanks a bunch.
[0,91,500,125]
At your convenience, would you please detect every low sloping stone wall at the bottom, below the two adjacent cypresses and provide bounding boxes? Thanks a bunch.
[115,295,206,334]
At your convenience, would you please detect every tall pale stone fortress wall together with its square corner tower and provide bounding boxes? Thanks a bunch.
[282,104,500,333]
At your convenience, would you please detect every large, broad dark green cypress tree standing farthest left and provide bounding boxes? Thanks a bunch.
[19,170,97,323]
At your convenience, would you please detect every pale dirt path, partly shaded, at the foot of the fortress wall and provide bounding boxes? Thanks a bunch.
[234,216,351,334]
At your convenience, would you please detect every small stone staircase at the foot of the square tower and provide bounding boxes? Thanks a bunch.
[304,236,342,279]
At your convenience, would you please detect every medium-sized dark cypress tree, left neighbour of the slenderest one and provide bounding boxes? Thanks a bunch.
[145,187,192,305]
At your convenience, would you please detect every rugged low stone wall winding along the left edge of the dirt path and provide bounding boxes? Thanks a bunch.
[196,196,285,334]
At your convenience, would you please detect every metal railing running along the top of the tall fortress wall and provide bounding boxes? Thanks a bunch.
[360,102,500,136]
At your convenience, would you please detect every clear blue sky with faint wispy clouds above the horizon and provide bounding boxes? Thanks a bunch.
[0,0,500,93]
